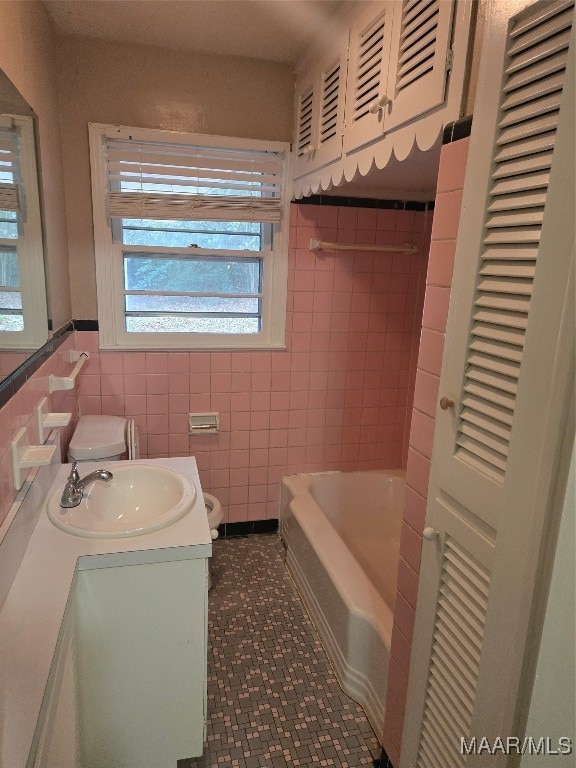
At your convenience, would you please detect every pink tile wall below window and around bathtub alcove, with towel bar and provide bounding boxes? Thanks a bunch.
[78,205,431,522]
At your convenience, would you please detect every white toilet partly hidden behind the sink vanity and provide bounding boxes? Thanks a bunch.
[68,416,223,539]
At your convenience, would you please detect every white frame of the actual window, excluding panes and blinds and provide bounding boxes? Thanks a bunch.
[88,123,290,350]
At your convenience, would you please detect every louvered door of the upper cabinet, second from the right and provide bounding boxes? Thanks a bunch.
[344,0,394,153]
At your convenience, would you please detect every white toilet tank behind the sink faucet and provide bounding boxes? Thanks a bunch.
[68,416,126,461]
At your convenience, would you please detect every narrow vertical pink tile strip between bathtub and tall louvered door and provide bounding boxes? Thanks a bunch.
[384,139,469,766]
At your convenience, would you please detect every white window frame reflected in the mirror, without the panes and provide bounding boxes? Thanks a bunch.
[0,114,48,350]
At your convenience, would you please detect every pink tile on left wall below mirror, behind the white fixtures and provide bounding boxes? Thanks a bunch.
[0,333,78,525]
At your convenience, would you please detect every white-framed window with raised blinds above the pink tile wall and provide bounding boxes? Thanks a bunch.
[90,125,289,349]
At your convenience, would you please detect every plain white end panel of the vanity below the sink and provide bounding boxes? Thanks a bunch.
[76,558,208,768]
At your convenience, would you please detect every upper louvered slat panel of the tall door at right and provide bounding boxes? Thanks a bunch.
[455,2,573,481]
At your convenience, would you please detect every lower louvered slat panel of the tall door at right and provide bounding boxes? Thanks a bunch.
[417,535,490,768]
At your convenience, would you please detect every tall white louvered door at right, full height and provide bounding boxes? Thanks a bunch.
[401,0,575,768]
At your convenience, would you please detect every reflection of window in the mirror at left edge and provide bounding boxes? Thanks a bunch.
[0,115,48,349]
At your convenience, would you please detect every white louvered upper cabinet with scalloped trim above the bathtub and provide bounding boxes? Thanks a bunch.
[294,0,473,197]
